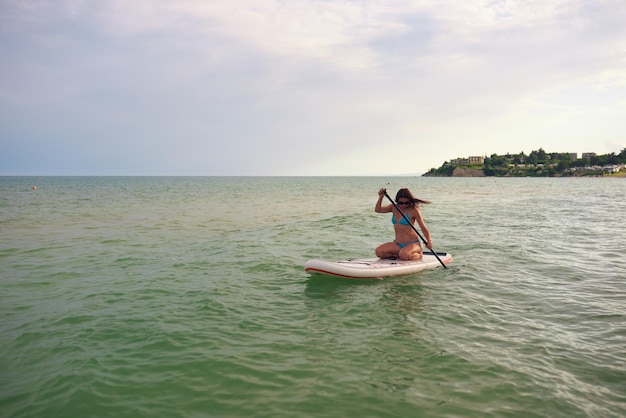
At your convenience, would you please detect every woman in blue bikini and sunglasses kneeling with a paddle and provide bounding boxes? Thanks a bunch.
[374,189,433,260]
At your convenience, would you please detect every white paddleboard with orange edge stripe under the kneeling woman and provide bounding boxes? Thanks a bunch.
[304,251,452,279]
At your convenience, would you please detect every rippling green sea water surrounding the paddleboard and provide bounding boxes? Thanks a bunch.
[0,177,626,418]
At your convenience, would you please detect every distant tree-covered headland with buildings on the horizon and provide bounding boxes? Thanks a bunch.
[422,148,626,177]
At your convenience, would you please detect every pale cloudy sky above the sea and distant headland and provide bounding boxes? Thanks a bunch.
[0,0,626,176]
